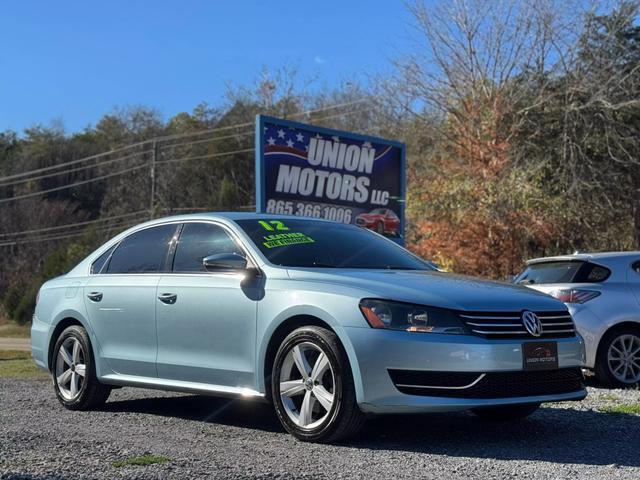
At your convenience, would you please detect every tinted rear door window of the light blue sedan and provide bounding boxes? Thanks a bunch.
[107,224,177,273]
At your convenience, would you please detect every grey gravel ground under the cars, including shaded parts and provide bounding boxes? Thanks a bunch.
[0,379,640,480]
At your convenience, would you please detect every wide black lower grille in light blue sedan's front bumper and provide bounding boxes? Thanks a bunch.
[389,368,584,399]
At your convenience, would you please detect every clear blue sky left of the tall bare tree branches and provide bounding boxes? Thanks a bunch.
[0,0,411,133]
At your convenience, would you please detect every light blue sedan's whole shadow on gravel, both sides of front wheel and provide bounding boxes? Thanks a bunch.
[102,395,640,467]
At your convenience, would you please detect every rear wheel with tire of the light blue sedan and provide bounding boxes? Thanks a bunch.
[51,325,111,410]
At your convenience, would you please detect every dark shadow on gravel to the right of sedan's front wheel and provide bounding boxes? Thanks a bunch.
[349,407,640,467]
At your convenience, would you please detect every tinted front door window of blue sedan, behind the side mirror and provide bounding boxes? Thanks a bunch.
[173,223,243,272]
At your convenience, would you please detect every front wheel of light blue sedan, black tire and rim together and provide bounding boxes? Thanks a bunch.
[271,326,365,442]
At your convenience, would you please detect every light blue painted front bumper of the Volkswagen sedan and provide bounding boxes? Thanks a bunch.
[345,327,587,413]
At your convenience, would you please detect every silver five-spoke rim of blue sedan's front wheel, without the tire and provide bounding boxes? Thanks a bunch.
[279,342,335,429]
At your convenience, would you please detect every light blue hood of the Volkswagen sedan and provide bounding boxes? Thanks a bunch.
[288,268,567,312]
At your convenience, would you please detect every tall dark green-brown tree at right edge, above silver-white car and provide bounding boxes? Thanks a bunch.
[514,2,640,249]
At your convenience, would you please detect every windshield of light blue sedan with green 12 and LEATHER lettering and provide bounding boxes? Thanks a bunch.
[236,218,434,270]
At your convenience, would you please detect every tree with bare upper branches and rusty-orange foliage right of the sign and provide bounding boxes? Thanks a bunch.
[382,0,584,277]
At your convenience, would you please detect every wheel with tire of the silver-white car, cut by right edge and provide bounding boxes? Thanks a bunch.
[594,326,640,388]
